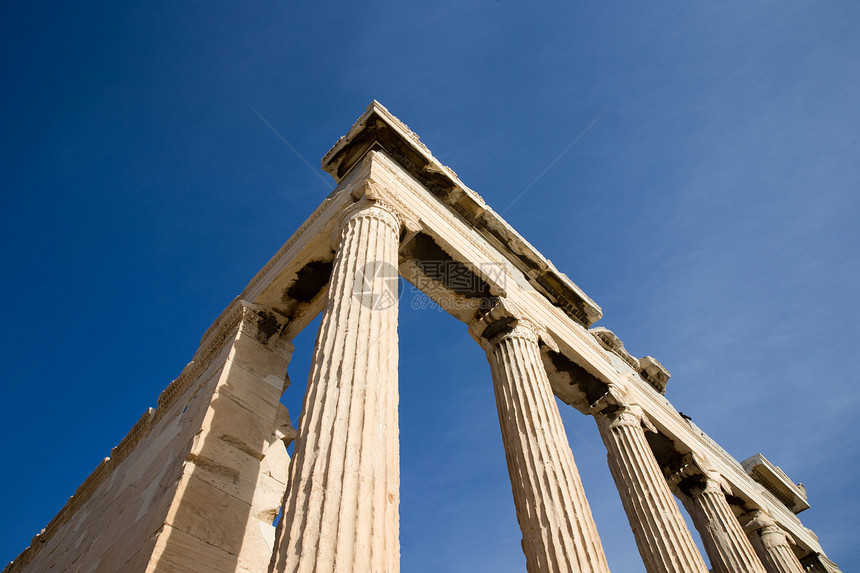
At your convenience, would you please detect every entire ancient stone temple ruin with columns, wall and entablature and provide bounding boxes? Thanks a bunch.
[5,102,839,573]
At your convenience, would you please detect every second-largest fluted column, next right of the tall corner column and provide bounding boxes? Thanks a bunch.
[478,305,609,573]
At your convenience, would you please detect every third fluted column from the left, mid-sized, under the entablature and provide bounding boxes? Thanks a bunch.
[595,405,708,573]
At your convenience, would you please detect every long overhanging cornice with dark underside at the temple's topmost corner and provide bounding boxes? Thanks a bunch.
[322,100,603,326]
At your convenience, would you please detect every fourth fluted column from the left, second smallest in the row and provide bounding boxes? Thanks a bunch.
[688,474,765,573]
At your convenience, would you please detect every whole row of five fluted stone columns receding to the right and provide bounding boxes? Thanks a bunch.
[270,199,803,573]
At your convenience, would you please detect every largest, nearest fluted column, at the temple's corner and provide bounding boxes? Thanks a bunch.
[273,202,401,573]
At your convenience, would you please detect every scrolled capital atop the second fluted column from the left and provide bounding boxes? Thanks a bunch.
[469,297,558,351]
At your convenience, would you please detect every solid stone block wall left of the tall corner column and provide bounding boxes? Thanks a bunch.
[4,301,294,573]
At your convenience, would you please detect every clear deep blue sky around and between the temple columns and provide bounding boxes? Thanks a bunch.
[0,0,860,573]
